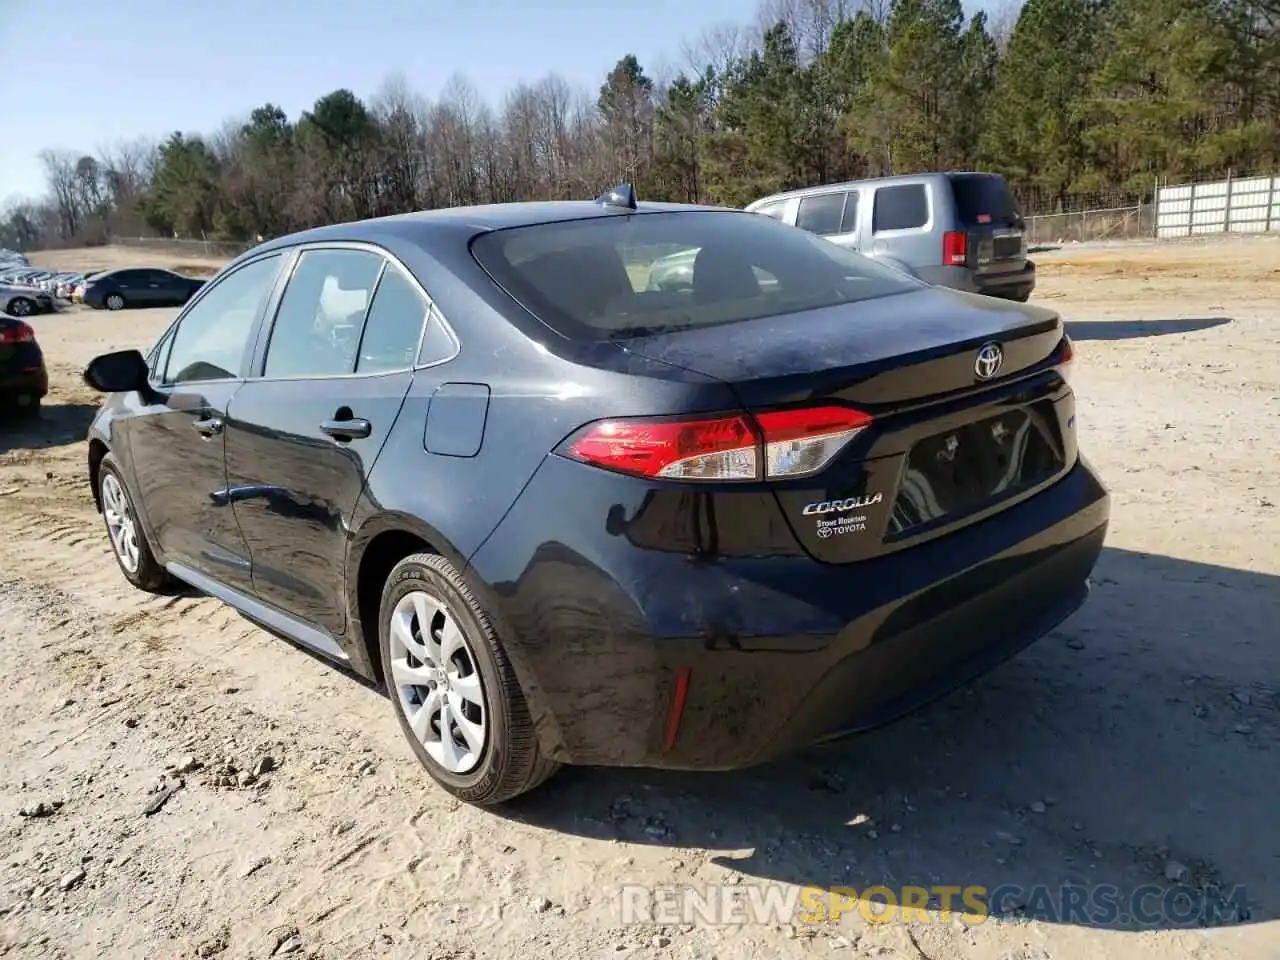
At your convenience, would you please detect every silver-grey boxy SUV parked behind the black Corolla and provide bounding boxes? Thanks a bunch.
[746,173,1036,301]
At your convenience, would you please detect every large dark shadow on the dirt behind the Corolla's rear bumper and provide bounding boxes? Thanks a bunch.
[503,548,1280,929]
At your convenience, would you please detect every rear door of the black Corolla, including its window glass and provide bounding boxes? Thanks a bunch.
[227,244,428,636]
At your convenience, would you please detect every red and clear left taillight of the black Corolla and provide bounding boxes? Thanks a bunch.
[566,407,872,480]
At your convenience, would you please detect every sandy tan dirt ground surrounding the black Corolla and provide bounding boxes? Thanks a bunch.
[0,238,1280,960]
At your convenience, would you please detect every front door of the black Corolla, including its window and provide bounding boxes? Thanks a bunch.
[122,255,282,591]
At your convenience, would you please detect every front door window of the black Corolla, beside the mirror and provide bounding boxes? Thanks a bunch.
[161,253,280,384]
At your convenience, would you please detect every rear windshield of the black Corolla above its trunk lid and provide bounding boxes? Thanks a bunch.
[471,210,920,340]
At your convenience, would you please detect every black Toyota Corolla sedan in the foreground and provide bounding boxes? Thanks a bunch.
[84,187,1108,804]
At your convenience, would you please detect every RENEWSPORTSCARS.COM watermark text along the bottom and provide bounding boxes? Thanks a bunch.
[618,883,1249,928]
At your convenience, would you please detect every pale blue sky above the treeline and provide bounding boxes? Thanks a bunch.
[0,0,998,205]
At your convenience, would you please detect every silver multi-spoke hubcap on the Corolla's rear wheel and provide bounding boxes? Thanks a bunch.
[390,590,489,773]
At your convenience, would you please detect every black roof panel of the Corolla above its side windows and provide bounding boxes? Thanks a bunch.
[242,200,741,257]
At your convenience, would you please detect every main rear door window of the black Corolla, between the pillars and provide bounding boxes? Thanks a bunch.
[262,250,385,379]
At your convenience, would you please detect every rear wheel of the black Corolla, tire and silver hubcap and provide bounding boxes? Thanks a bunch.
[378,553,559,805]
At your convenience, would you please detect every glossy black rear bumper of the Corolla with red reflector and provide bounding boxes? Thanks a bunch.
[470,457,1110,769]
